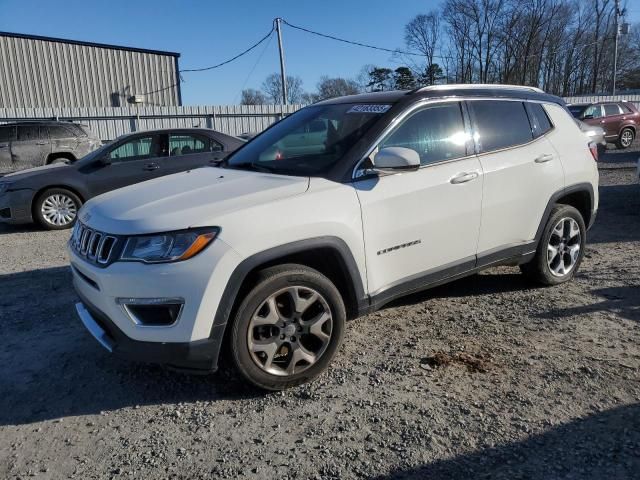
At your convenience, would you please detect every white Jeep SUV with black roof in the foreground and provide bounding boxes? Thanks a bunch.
[69,85,598,390]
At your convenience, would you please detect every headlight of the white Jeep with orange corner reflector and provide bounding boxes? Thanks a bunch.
[120,228,220,263]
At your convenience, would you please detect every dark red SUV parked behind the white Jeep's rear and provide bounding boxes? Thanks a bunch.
[568,102,640,148]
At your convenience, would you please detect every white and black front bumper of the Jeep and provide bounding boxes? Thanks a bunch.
[68,234,240,371]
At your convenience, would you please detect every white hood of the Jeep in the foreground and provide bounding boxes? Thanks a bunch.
[79,167,309,235]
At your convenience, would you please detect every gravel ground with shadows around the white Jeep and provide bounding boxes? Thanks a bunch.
[0,144,640,479]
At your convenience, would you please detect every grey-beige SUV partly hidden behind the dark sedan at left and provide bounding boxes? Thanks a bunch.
[0,121,102,173]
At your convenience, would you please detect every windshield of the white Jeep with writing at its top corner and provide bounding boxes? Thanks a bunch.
[223,104,391,176]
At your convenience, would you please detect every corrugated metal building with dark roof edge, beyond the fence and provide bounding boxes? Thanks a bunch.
[0,32,182,108]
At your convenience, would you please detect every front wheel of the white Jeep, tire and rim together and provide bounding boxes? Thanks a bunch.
[228,264,346,390]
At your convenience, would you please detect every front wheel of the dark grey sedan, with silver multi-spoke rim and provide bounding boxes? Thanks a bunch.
[33,188,82,230]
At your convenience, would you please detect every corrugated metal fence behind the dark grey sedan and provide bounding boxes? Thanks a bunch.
[0,105,302,140]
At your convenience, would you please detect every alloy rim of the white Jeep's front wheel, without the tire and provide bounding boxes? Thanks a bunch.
[247,286,333,376]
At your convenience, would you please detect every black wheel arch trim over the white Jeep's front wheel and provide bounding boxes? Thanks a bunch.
[211,236,368,335]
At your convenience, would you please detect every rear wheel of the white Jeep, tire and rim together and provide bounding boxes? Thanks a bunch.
[520,205,586,285]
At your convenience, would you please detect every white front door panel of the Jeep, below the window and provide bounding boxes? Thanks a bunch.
[353,157,482,294]
